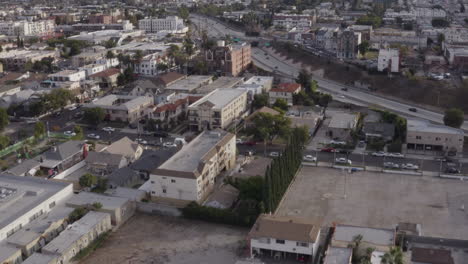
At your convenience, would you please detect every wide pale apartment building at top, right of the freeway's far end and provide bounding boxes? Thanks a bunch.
[273,13,317,31]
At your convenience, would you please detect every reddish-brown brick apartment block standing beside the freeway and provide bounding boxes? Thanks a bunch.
[205,40,252,76]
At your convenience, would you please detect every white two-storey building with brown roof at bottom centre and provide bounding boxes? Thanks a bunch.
[248,214,322,263]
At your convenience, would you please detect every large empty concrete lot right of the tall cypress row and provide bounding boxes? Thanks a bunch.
[277,167,468,239]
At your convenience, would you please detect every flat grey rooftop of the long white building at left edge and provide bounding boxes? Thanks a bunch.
[0,174,73,234]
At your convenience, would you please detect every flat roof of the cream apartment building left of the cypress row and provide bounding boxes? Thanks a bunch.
[156,129,234,177]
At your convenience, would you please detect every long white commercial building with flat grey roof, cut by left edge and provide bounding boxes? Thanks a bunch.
[0,174,73,241]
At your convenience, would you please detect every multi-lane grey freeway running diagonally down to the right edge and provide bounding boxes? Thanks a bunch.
[191,12,468,132]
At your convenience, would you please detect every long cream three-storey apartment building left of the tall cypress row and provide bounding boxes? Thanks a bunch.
[139,129,236,203]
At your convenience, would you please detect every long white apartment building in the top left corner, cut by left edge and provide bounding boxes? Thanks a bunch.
[0,20,55,36]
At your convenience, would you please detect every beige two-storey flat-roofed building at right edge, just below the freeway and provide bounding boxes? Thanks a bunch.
[406,119,464,155]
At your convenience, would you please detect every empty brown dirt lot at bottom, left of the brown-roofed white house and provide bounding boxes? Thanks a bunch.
[80,214,248,264]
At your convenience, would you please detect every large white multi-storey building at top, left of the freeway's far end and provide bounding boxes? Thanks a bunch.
[138,16,188,33]
